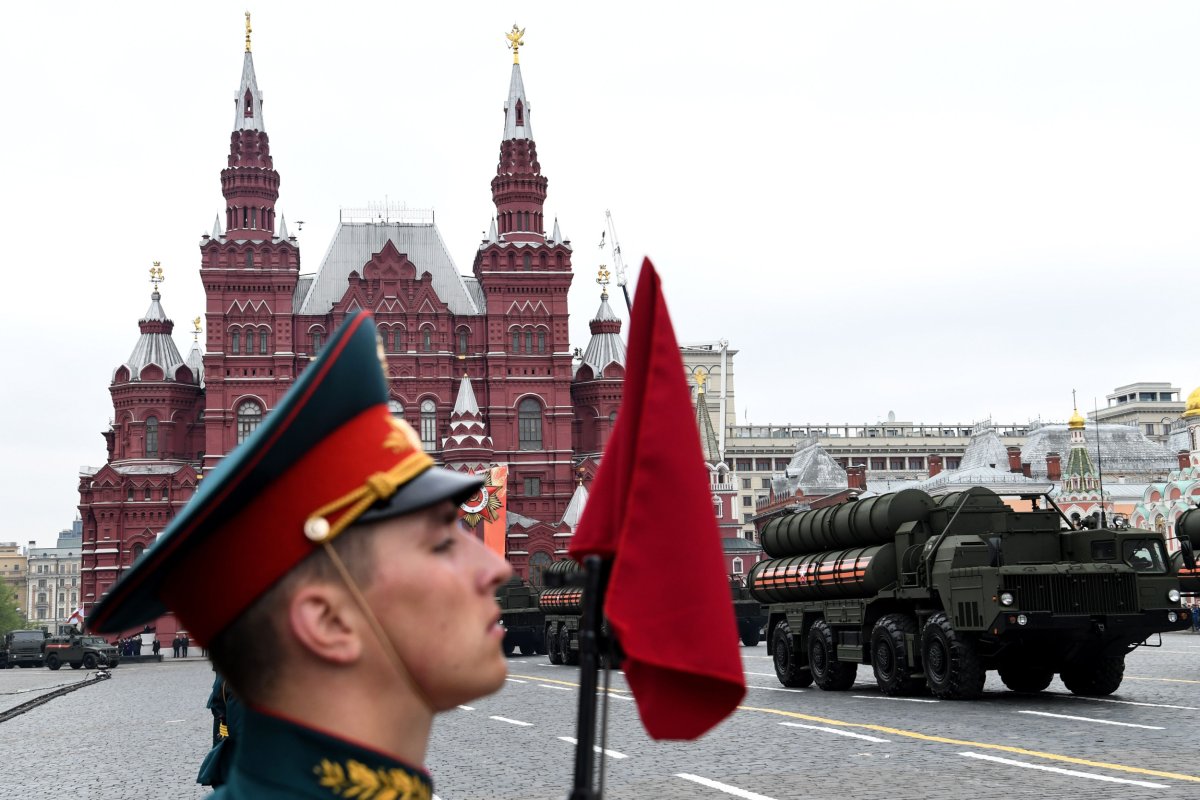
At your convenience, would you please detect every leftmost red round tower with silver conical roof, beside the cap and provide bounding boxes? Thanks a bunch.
[79,271,204,633]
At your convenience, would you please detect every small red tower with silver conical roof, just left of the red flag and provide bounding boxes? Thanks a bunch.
[571,268,625,456]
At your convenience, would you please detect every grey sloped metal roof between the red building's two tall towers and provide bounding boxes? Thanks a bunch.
[295,222,482,314]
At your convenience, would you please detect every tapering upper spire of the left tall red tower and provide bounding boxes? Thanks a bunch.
[221,11,280,241]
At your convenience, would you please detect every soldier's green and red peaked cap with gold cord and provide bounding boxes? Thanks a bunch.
[88,312,482,643]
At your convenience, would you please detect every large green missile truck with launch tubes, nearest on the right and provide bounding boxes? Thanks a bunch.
[748,487,1188,699]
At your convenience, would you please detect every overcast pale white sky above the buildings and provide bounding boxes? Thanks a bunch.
[0,0,1200,545]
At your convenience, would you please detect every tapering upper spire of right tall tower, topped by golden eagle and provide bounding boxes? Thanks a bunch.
[492,25,547,243]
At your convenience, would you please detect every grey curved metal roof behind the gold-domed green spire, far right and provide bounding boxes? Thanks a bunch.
[1021,422,1178,479]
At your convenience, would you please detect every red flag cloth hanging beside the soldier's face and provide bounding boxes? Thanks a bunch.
[570,259,745,739]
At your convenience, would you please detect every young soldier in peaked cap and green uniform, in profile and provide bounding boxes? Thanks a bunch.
[89,313,511,800]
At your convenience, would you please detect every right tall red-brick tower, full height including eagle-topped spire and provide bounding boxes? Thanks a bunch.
[473,25,575,519]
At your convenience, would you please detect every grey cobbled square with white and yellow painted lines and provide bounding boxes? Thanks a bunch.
[0,634,1200,800]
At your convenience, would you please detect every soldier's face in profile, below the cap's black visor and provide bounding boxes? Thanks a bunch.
[365,501,512,710]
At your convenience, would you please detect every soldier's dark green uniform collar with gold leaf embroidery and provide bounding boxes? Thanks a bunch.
[210,708,433,800]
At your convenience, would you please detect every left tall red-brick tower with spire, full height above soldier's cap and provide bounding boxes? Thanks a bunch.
[200,12,301,468]
